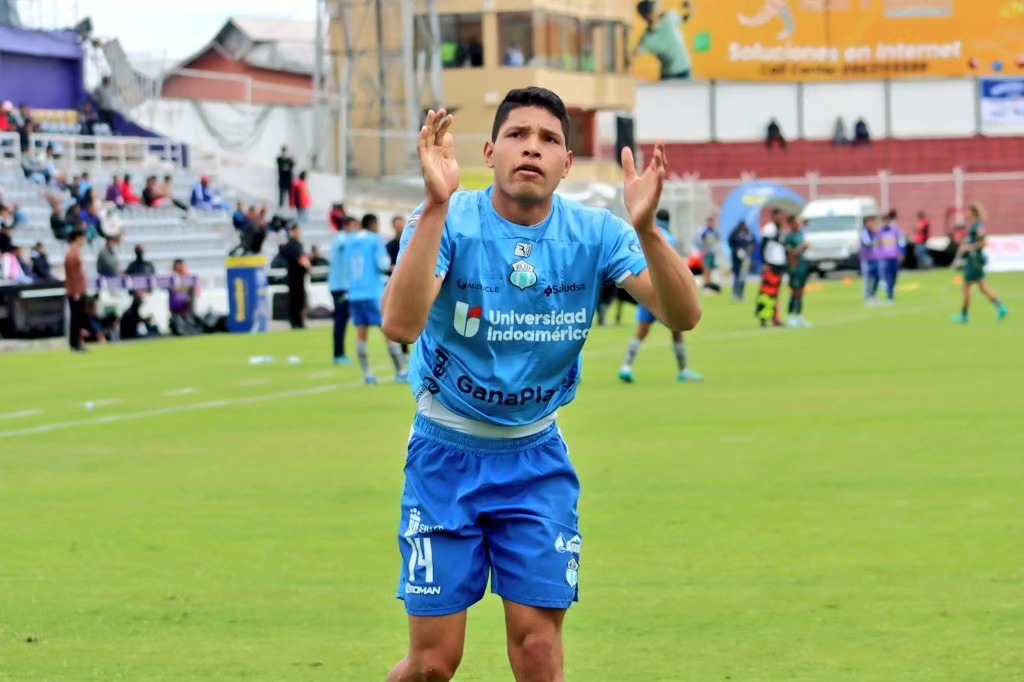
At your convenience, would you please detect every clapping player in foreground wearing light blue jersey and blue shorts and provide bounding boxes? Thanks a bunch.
[383,88,700,682]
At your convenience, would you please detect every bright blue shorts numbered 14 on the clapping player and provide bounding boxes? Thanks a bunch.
[397,415,583,616]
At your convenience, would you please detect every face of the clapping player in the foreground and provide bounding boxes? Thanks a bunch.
[483,106,572,204]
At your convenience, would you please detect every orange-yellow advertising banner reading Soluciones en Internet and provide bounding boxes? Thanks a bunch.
[632,0,1024,82]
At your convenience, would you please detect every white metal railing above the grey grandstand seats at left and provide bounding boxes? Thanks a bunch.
[29,133,185,170]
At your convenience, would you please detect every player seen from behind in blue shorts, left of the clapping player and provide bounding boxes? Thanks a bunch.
[341,223,406,384]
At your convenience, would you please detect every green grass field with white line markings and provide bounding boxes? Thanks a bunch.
[0,272,1024,682]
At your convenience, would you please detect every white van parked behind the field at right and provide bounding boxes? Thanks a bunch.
[800,197,882,273]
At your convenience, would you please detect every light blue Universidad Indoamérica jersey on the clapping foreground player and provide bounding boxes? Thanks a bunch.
[398,189,647,426]
